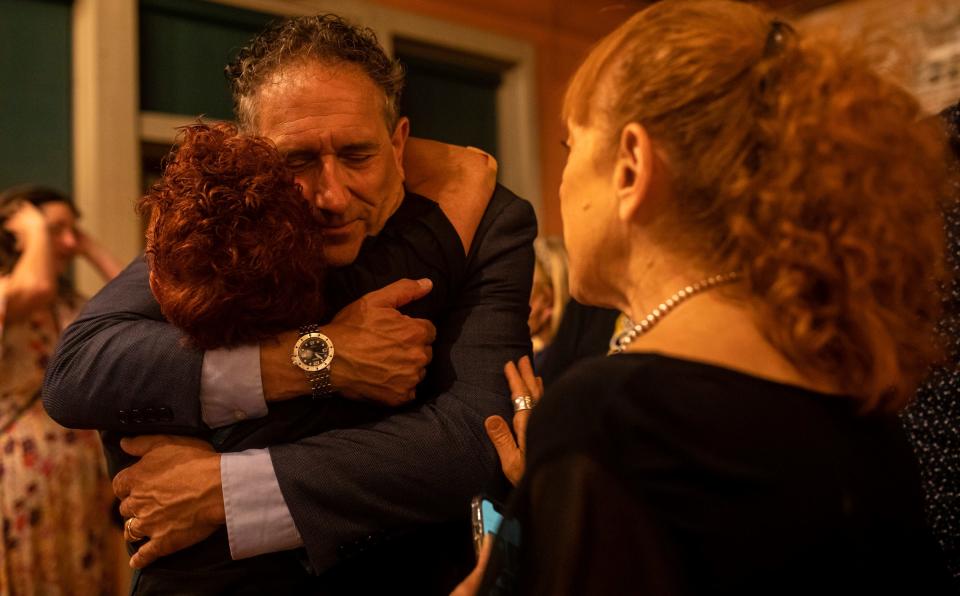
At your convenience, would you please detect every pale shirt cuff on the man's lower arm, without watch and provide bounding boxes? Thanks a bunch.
[220,449,303,560]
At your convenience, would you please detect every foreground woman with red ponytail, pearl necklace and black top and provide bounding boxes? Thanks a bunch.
[461,0,951,595]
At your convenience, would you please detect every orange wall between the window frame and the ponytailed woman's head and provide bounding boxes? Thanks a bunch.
[374,0,643,234]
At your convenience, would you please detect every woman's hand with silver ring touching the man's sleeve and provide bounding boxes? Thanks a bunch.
[483,356,543,486]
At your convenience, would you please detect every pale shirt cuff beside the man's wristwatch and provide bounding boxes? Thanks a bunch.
[200,344,267,428]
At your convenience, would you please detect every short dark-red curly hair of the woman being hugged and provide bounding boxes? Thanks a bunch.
[138,123,325,350]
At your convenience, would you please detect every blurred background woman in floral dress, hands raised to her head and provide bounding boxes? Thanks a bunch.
[0,187,120,594]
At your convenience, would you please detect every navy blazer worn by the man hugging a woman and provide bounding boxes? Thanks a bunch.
[43,186,536,593]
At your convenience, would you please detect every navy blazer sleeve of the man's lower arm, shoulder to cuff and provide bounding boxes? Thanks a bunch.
[270,188,536,572]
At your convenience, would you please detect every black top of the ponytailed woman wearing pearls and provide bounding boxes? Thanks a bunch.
[481,353,949,595]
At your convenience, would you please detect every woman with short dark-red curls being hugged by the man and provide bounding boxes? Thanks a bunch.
[138,123,495,350]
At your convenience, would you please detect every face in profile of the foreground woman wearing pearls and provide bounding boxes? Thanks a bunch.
[560,122,617,304]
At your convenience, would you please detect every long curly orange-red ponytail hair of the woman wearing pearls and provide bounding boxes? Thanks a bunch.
[564,0,950,410]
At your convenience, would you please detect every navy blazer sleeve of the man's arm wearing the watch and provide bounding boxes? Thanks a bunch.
[43,257,209,434]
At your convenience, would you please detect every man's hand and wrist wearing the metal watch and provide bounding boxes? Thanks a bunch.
[260,279,436,406]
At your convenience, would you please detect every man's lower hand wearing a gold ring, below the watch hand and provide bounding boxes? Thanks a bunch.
[113,435,226,569]
